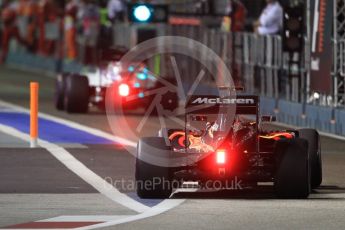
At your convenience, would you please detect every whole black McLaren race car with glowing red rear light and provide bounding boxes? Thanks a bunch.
[135,92,322,198]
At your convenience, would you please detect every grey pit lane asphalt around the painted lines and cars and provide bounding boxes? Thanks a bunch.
[0,67,345,229]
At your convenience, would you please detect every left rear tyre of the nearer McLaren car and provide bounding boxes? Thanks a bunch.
[135,137,172,199]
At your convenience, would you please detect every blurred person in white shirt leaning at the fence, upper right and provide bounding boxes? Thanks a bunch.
[254,0,283,35]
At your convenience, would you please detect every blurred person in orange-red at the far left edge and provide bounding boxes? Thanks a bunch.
[0,0,25,63]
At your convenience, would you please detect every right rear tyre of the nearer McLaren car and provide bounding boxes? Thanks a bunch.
[274,139,310,199]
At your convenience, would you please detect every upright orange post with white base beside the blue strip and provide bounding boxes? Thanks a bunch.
[30,82,39,148]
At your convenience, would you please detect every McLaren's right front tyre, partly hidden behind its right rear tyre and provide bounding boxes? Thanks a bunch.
[298,129,322,189]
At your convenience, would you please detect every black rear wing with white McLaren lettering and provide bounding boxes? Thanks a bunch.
[186,95,259,115]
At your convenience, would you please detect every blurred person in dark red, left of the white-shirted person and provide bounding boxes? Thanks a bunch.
[222,0,247,32]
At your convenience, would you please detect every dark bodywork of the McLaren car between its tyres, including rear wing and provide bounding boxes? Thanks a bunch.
[167,96,298,183]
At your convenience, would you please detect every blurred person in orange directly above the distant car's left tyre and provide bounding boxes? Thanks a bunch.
[64,0,79,60]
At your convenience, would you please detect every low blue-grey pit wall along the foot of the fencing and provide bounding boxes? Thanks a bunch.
[7,53,345,136]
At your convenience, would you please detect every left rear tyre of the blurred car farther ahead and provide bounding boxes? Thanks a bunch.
[64,74,90,113]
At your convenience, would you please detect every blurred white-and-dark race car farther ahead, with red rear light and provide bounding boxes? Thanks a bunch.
[55,48,178,113]
